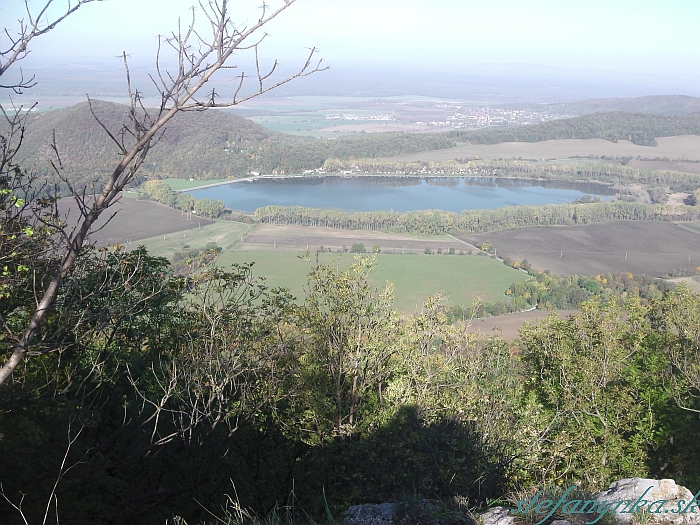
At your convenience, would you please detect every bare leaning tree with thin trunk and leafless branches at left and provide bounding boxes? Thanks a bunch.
[0,0,327,384]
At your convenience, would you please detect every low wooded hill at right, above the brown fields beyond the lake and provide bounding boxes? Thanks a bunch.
[452,111,700,146]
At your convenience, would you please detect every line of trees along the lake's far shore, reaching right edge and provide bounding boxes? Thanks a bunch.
[323,158,700,191]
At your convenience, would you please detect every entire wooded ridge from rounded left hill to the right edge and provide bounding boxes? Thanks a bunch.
[15,101,700,190]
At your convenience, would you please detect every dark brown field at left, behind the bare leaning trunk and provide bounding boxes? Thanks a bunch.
[59,197,214,246]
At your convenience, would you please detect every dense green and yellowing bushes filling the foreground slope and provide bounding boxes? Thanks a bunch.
[0,243,700,524]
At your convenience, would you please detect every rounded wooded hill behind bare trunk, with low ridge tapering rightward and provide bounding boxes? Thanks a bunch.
[16,101,454,181]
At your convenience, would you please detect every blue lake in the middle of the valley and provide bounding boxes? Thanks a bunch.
[187,177,615,212]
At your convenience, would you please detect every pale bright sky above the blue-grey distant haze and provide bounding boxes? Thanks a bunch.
[0,0,700,74]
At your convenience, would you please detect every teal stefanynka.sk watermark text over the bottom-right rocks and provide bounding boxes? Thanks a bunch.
[511,486,700,525]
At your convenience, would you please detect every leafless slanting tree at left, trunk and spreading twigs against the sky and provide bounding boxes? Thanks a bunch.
[0,0,323,384]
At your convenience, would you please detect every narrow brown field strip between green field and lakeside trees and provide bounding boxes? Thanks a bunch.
[238,224,469,253]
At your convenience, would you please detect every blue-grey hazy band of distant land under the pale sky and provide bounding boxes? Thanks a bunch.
[5,57,700,105]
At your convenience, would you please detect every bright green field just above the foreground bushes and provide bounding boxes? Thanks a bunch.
[217,251,530,313]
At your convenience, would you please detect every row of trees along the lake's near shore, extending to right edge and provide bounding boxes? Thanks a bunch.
[255,201,700,235]
